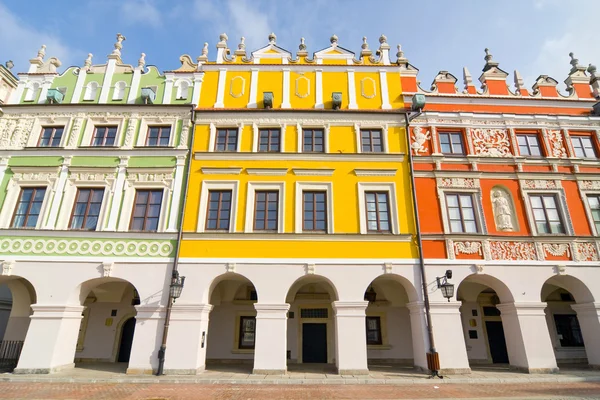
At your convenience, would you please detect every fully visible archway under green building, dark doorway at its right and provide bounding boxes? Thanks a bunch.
[75,278,140,372]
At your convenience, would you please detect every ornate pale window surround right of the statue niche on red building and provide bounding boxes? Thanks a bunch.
[519,179,576,236]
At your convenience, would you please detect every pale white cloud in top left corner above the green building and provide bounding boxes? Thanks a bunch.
[0,3,83,73]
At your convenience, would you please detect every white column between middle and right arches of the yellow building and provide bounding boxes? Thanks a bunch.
[332,301,369,375]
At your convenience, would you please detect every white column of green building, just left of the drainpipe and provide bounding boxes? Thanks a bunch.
[127,305,165,375]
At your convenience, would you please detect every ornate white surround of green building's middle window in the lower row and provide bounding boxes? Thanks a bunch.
[56,168,116,231]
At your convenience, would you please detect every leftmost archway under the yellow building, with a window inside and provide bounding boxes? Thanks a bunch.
[206,273,258,373]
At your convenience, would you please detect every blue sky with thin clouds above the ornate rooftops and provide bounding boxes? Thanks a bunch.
[0,0,600,89]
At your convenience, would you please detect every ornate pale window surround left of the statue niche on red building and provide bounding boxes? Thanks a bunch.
[436,178,488,235]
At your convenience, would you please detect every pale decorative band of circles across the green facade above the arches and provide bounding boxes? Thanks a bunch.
[0,238,173,257]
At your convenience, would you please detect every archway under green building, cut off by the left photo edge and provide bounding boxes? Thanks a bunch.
[0,276,37,372]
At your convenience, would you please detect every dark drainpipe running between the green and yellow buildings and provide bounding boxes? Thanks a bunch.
[156,104,196,376]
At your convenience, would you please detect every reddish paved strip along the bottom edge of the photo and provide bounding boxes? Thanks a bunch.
[0,382,600,400]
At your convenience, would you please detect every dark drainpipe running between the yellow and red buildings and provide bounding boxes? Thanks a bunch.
[404,110,442,378]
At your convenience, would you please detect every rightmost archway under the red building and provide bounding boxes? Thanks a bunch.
[541,275,600,368]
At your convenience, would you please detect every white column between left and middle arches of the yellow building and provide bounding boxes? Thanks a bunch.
[252,303,290,375]
